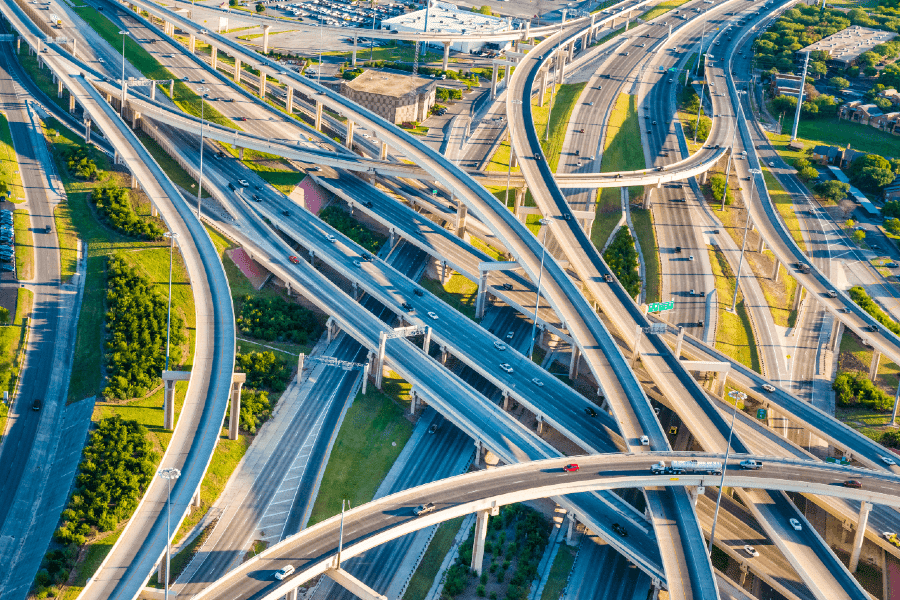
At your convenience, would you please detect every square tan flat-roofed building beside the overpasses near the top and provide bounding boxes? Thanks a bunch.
[341,70,437,124]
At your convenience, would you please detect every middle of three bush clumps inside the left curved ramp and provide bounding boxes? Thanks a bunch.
[103,256,185,400]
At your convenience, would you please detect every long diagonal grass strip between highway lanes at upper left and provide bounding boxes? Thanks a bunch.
[69,6,239,129]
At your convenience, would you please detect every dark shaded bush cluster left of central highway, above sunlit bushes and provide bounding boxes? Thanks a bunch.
[237,296,319,344]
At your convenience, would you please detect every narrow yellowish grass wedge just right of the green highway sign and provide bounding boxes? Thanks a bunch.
[708,247,760,373]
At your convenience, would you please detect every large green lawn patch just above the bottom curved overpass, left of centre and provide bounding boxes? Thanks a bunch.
[309,377,412,526]
